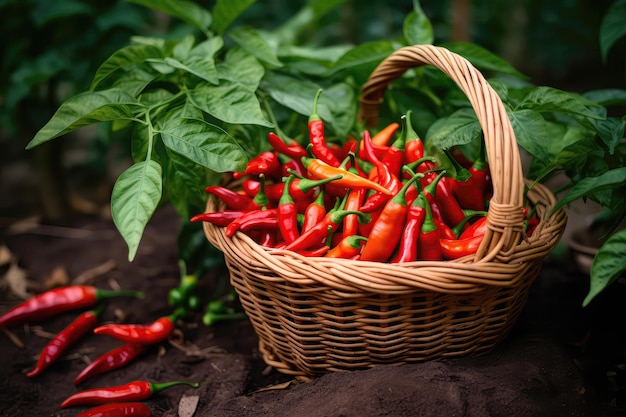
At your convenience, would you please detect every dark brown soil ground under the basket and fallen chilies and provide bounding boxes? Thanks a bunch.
[0,209,626,417]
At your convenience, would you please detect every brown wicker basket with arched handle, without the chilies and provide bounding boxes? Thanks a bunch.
[204,45,566,379]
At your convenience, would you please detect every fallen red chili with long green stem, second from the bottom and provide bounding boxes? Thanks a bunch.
[61,381,198,408]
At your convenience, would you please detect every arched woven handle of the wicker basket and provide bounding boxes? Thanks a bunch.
[359,45,524,262]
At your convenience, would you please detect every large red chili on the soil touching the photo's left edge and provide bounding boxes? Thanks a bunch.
[0,285,143,327]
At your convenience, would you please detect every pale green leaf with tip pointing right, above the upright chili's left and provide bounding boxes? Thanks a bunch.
[188,80,273,127]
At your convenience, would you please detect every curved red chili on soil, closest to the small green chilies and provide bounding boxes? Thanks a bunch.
[93,309,183,345]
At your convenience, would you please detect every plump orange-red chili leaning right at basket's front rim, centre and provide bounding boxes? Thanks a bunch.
[361,174,423,262]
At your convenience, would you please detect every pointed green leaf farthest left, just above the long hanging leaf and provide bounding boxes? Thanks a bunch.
[26,89,140,149]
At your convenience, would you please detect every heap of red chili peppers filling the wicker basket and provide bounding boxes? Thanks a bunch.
[191,92,538,263]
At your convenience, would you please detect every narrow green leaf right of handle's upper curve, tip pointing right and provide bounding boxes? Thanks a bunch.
[517,87,604,119]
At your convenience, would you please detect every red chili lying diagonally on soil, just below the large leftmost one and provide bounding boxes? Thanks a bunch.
[26,305,103,378]
